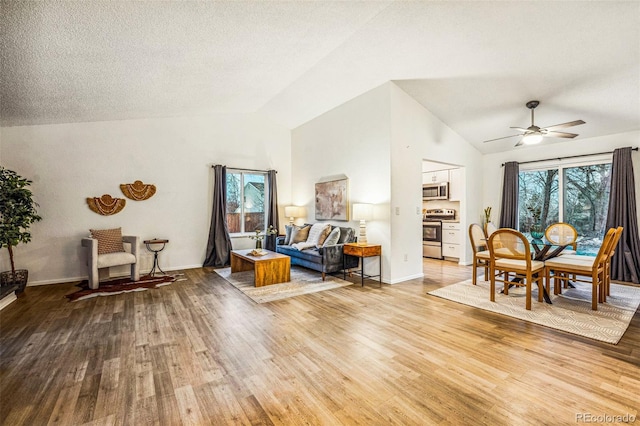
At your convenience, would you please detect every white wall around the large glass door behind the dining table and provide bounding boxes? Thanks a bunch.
[482,131,640,233]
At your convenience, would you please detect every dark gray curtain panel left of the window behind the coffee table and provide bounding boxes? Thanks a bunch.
[202,165,231,267]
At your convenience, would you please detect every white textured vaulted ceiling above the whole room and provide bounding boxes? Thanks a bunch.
[0,1,640,153]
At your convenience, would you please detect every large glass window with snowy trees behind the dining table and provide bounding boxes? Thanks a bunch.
[518,162,611,256]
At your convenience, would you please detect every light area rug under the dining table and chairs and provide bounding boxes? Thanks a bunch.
[428,280,640,344]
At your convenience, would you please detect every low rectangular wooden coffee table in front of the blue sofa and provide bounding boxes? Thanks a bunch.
[231,249,291,287]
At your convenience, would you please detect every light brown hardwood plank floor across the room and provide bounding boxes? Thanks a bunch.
[0,260,640,425]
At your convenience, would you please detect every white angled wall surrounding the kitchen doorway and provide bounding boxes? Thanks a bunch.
[391,84,483,268]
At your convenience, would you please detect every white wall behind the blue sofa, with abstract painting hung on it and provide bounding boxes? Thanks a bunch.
[291,83,391,282]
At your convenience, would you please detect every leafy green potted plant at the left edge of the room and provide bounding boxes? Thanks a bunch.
[0,166,42,293]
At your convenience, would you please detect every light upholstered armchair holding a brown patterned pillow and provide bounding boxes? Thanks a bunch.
[82,235,140,289]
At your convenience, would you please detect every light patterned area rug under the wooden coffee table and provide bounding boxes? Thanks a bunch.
[215,266,353,303]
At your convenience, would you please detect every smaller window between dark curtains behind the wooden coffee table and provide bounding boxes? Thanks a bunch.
[227,169,268,234]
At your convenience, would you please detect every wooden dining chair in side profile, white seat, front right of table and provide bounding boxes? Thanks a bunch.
[545,228,616,311]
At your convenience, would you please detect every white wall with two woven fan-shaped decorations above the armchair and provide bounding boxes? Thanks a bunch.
[0,114,291,284]
